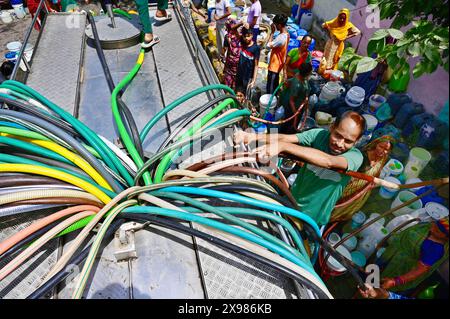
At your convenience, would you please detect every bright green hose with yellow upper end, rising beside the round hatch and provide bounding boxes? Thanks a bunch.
[111,49,151,185]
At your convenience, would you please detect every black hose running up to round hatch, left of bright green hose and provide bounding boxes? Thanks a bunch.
[87,12,144,158]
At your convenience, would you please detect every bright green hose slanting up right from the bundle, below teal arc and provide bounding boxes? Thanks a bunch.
[155,99,237,183]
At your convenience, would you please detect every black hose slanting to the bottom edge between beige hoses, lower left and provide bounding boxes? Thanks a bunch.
[26,219,124,299]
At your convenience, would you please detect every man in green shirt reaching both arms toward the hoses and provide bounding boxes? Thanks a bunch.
[234,111,366,226]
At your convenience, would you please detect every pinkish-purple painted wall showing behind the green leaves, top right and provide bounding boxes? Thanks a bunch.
[351,0,449,115]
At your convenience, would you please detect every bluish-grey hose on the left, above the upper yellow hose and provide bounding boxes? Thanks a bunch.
[0,109,121,193]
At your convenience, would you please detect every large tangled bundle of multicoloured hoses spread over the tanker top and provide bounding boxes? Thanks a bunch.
[0,18,332,298]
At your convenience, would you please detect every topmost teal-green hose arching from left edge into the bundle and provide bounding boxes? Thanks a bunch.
[0,80,133,185]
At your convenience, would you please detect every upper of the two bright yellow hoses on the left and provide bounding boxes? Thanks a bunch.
[1,133,113,191]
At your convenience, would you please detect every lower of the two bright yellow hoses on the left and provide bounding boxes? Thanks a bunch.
[0,164,111,204]
